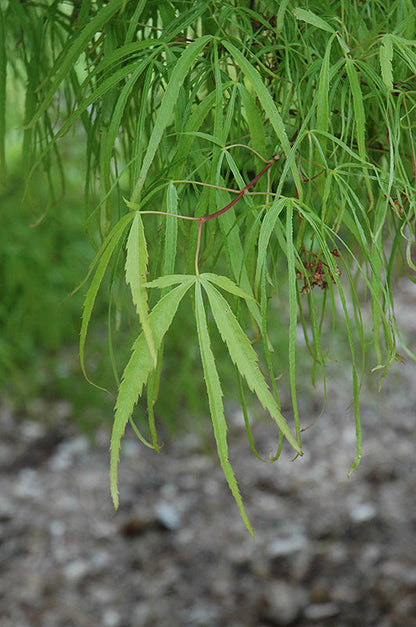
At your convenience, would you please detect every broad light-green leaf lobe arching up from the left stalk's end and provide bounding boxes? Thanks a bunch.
[131,35,212,202]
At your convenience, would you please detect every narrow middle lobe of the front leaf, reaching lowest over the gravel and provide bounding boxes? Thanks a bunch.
[195,280,254,537]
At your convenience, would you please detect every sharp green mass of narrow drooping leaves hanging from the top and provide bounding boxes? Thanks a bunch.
[0,0,416,530]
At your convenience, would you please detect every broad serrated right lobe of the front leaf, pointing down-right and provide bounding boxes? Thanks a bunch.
[201,280,303,455]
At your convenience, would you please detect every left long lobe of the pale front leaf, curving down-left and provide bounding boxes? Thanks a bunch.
[110,277,195,509]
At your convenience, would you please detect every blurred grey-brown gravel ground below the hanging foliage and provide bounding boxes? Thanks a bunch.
[0,288,416,627]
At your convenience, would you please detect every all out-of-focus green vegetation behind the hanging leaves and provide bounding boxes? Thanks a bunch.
[0,125,235,435]
